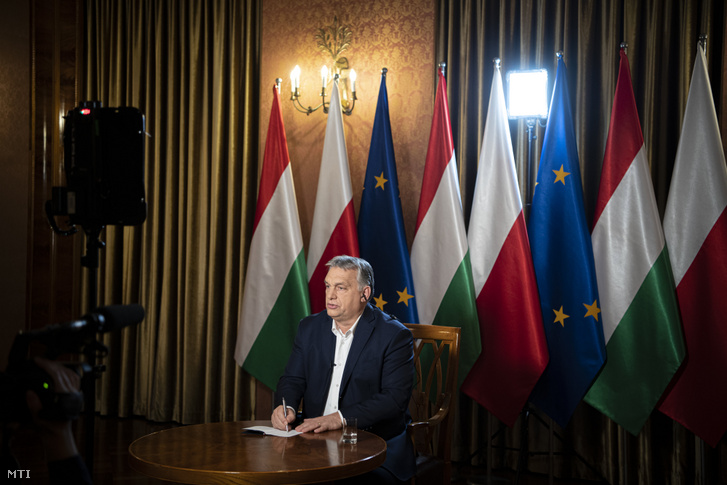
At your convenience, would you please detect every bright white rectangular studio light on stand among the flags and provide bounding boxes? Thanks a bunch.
[510,59,548,218]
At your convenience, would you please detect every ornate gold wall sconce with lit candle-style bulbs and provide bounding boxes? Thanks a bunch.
[290,17,357,116]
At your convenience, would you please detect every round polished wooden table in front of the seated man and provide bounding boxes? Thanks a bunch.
[129,421,386,484]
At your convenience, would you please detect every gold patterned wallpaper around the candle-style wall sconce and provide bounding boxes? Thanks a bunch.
[260,0,436,250]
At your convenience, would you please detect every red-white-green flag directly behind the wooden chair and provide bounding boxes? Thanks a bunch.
[411,70,482,385]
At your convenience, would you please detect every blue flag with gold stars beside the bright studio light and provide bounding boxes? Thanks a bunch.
[528,57,606,427]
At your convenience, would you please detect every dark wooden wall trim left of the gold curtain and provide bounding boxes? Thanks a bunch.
[26,0,83,328]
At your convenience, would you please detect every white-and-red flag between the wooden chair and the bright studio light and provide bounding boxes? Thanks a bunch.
[462,62,548,426]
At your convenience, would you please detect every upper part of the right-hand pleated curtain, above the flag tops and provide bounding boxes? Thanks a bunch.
[436,0,725,223]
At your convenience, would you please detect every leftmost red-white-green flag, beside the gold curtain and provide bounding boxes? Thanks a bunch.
[235,87,310,390]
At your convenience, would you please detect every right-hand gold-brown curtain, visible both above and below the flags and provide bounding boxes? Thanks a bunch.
[436,0,727,484]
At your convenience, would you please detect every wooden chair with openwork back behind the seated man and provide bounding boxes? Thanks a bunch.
[405,323,461,485]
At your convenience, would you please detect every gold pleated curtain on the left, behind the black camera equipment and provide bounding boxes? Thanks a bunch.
[81,0,259,423]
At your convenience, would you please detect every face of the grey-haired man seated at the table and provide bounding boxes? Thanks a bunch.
[325,268,371,326]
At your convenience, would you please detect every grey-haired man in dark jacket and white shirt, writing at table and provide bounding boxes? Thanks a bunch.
[271,256,415,483]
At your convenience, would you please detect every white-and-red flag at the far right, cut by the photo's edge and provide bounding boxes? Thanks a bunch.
[659,46,727,446]
